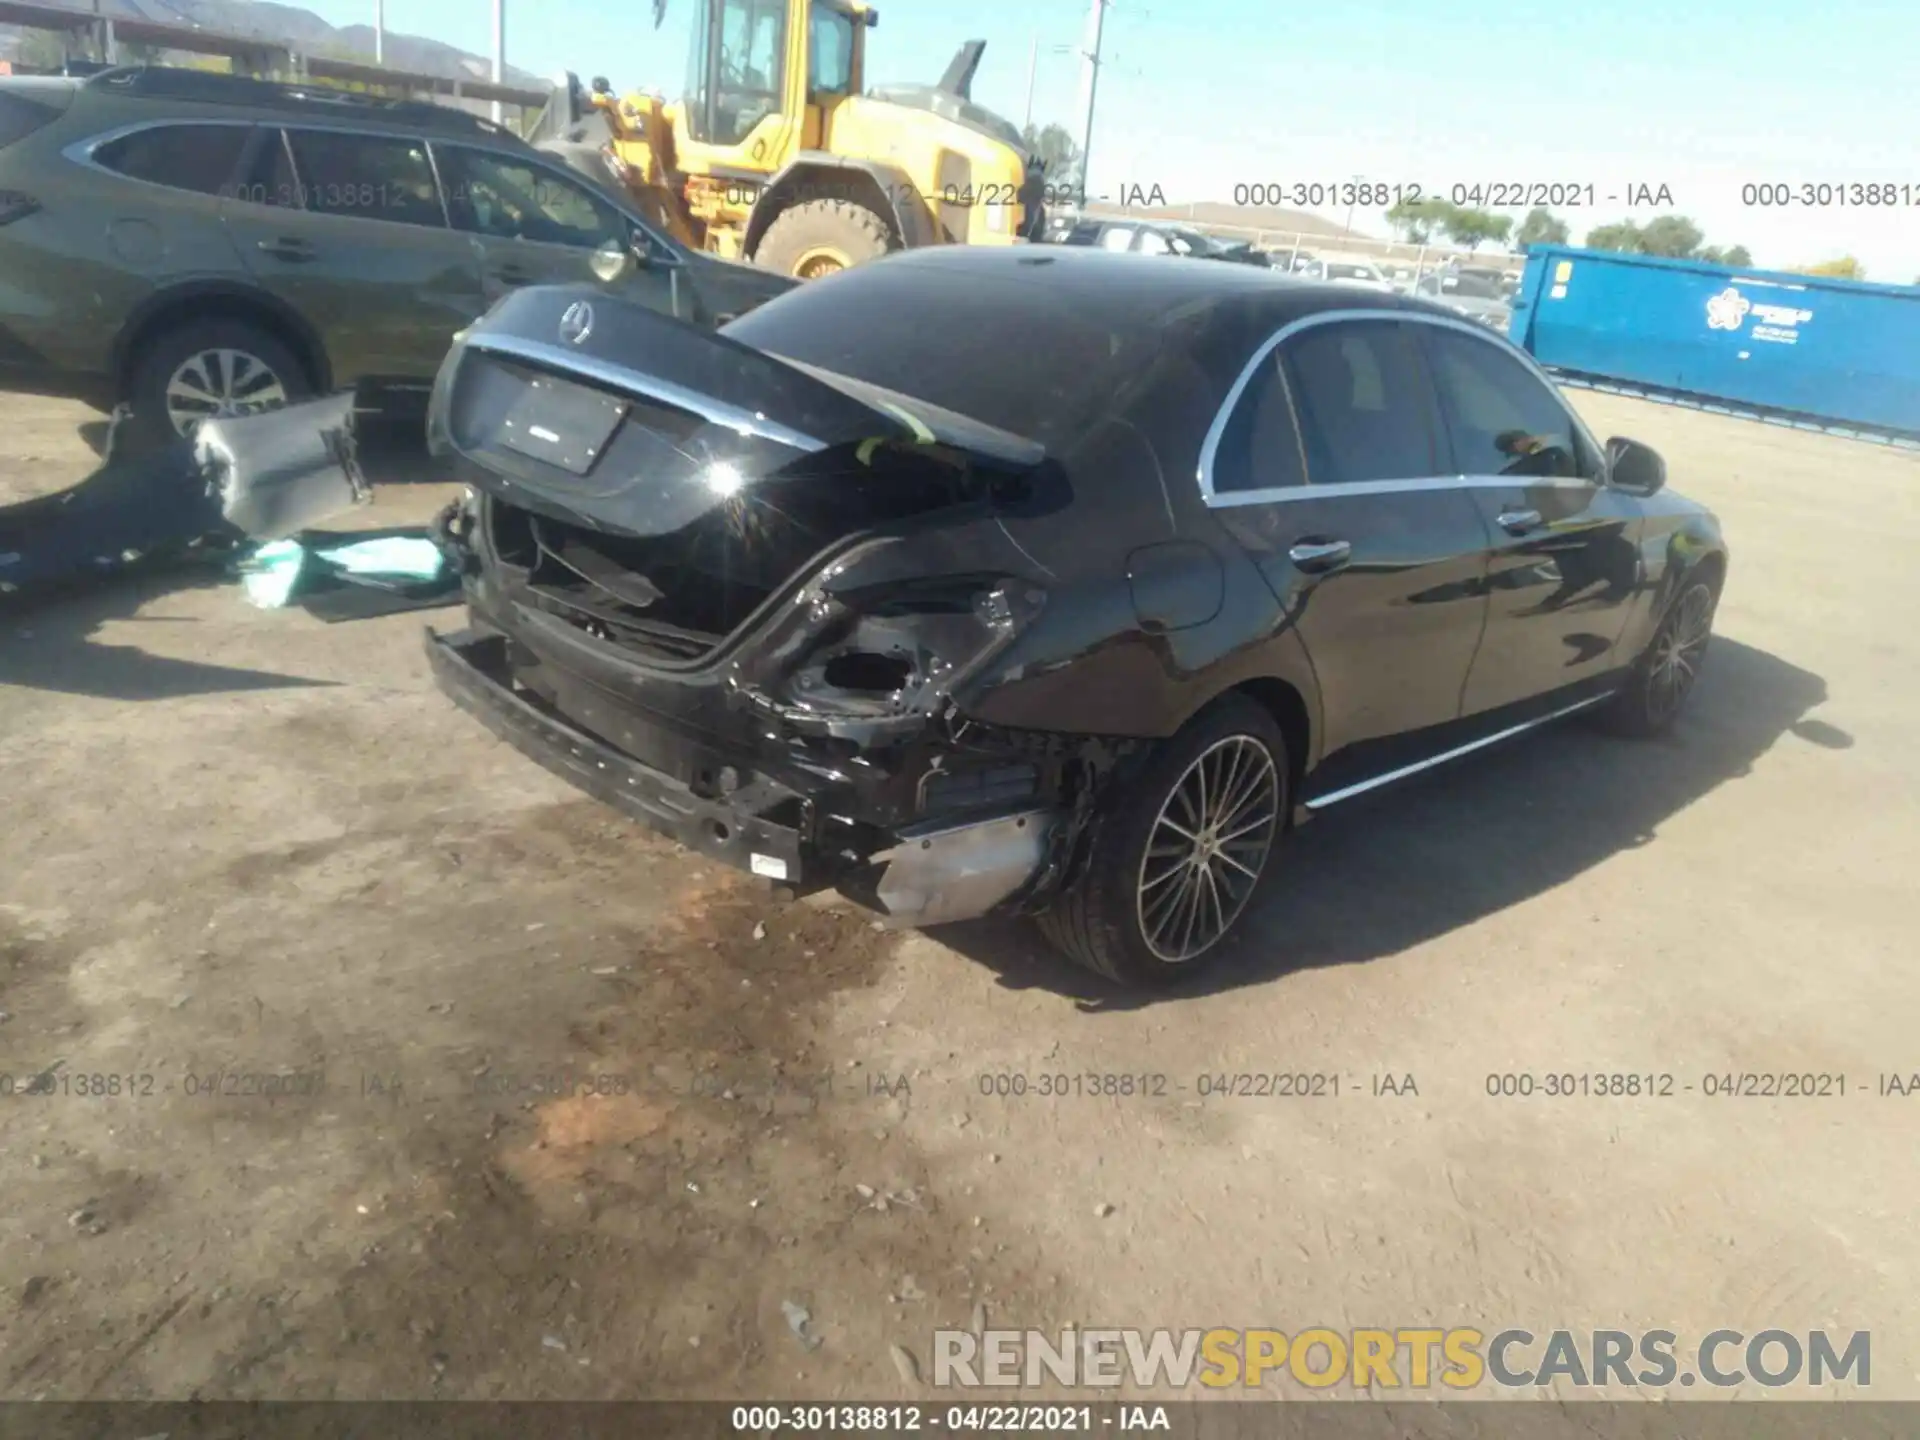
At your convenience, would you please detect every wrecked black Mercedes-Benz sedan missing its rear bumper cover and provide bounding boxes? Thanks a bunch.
[428,246,1726,985]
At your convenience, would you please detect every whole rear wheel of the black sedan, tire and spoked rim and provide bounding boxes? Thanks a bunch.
[1041,695,1288,985]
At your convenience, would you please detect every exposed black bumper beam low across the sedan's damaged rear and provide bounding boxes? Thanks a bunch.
[426,630,812,885]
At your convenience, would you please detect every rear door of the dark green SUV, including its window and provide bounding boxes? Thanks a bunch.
[221,127,484,384]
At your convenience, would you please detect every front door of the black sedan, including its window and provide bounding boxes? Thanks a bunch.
[1419,324,1640,714]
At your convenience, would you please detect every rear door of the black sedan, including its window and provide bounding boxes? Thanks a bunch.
[1202,317,1488,801]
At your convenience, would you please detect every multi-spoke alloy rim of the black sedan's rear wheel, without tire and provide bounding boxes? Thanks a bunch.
[1137,735,1281,964]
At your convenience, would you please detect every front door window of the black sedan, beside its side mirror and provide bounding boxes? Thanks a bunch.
[1425,326,1599,480]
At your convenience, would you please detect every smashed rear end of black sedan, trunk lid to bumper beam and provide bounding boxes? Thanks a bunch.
[430,268,1152,940]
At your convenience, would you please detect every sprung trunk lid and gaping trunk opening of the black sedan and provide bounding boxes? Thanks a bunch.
[428,288,1044,664]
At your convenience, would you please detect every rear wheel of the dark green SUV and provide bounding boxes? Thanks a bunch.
[127,319,313,445]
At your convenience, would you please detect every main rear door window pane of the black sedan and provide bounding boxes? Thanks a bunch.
[1281,321,1440,486]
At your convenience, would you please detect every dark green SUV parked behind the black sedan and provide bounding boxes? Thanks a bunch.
[0,67,793,444]
